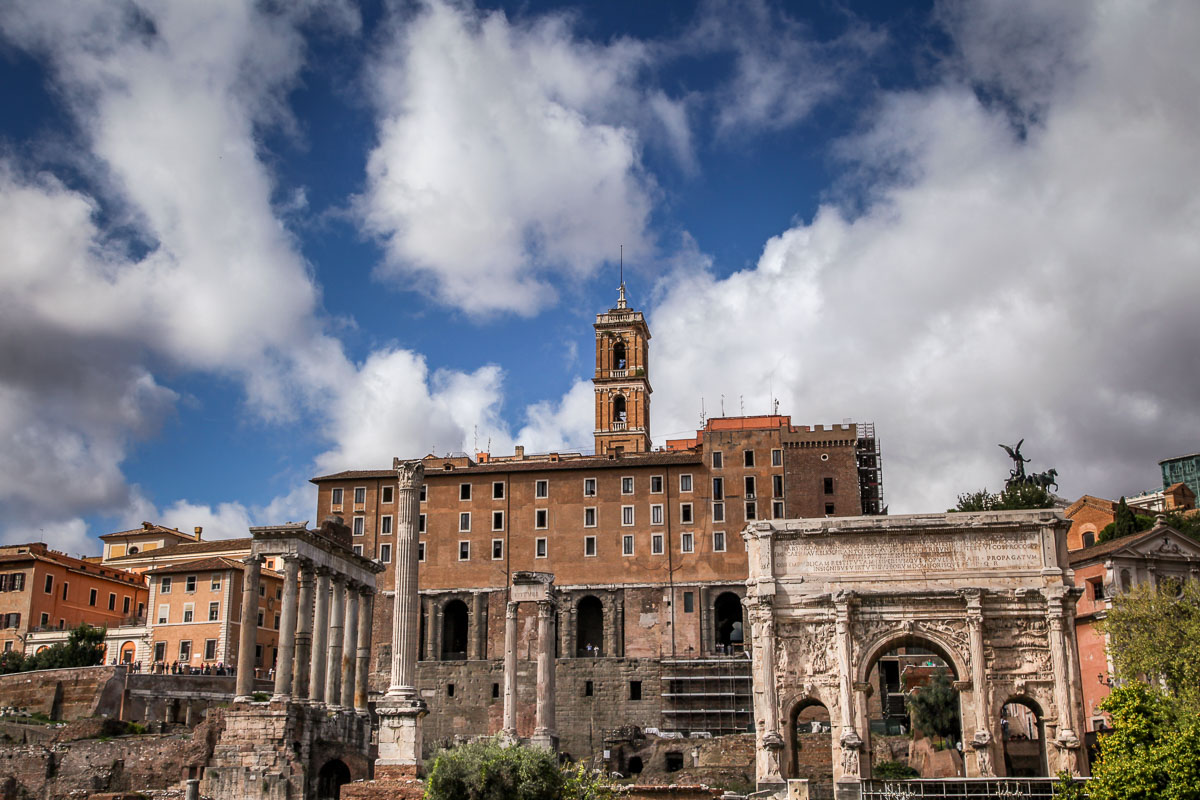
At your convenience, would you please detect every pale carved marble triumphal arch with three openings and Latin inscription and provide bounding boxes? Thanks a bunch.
[743,510,1087,796]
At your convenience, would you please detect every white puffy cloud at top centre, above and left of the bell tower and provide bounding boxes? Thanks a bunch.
[358,0,667,314]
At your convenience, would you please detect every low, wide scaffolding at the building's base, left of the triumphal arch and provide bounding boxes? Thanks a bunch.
[661,655,754,736]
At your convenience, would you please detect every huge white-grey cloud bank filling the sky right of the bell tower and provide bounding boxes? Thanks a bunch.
[652,2,1200,511]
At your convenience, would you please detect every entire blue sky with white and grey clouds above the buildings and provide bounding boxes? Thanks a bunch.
[0,0,1200,553]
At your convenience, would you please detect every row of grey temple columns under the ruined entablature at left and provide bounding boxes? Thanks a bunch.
[234,554,374,714]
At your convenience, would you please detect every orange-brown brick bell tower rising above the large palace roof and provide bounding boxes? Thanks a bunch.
[592,281,654,455]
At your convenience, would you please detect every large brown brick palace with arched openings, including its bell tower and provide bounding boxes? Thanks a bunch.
[313,293,882,756]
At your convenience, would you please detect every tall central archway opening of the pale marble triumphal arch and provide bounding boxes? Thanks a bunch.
[866,636,965,777]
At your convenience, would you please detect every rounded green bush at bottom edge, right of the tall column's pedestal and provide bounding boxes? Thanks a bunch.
[425,738,564,800]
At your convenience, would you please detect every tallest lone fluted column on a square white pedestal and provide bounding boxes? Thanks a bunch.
[376,458,428,778]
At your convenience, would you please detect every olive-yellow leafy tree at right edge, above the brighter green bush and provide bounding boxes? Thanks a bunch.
[1100,581,1200,716]
